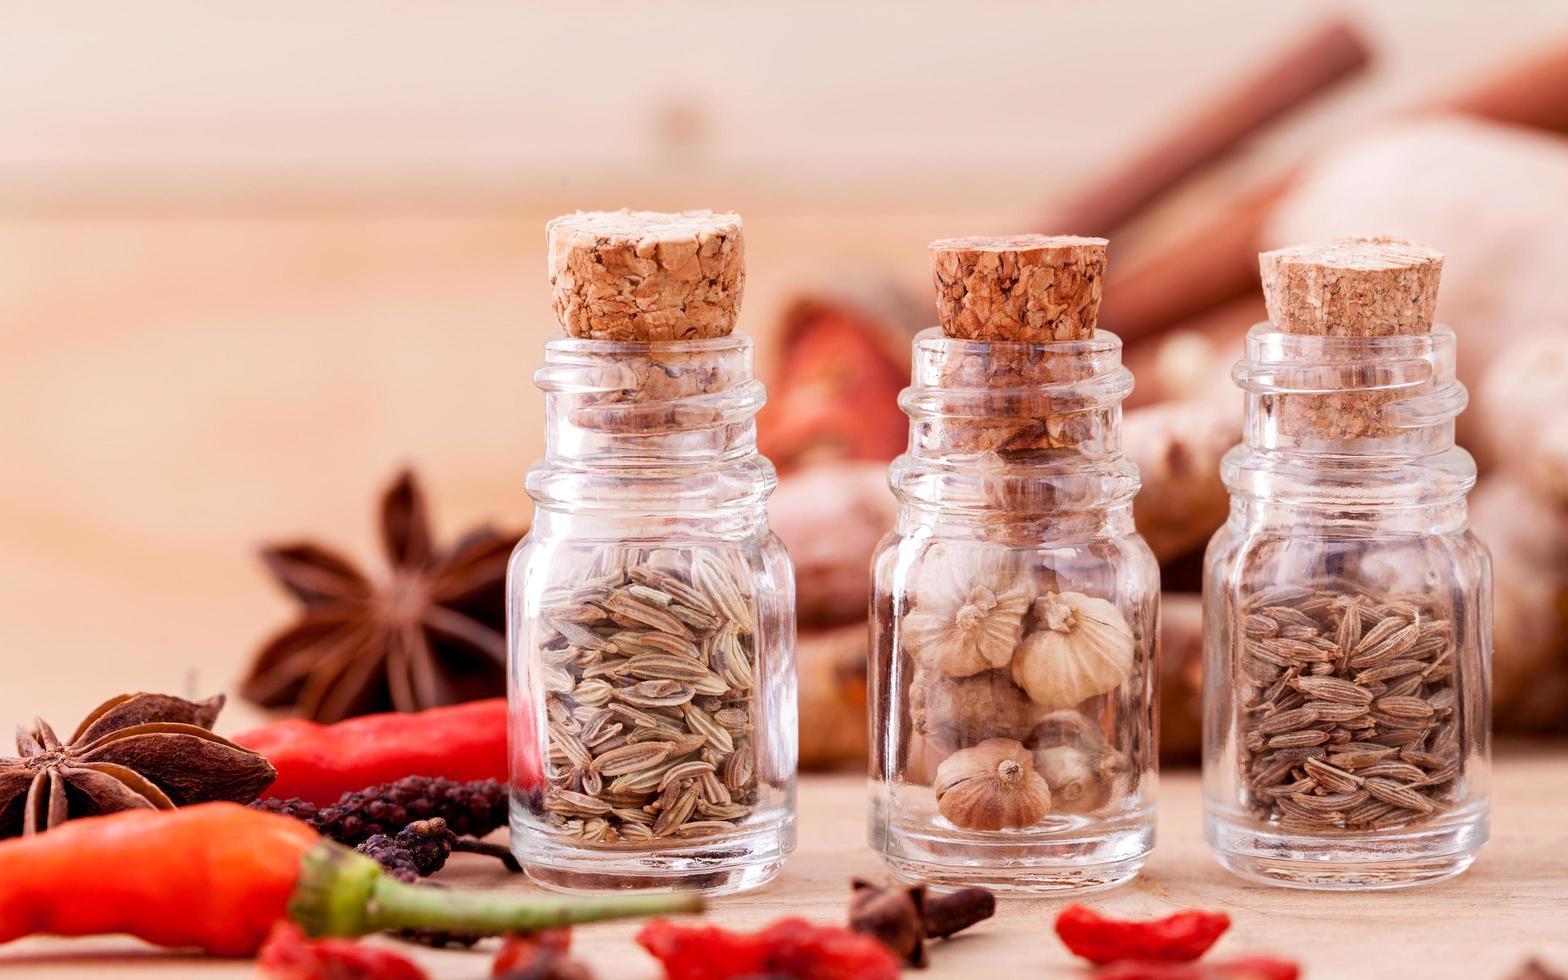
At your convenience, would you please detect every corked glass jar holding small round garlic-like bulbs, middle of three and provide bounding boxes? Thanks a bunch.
[870,235,1159,892]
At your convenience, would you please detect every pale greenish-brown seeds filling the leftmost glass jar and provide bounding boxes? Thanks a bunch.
[538,549,757,847]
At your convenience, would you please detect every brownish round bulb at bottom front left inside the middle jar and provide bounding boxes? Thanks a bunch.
[933,739,1051,831]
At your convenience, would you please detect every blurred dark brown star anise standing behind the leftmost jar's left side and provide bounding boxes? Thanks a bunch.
[243,470,517,721]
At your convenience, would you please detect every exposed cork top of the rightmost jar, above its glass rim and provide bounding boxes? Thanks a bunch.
[1258,238,1443,337]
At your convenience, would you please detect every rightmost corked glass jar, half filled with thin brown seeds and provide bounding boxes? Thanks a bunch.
[1204,240,1491,889]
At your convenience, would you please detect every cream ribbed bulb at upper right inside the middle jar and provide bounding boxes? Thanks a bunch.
[1013,593,1134,707]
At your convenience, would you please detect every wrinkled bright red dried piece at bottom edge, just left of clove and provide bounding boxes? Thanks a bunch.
[637,919,898,980]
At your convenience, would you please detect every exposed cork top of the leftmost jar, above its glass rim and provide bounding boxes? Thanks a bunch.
[544,210,746,340]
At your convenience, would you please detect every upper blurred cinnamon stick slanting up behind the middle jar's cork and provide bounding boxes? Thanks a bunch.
[1041,20,1370,235]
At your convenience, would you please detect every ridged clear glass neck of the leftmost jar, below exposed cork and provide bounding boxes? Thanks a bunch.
[527,334,778,525]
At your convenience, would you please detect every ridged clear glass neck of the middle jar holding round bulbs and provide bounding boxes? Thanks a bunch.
[889,328,1138,535]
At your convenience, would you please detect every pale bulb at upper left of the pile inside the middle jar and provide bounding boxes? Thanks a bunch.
[902,554,1030,677]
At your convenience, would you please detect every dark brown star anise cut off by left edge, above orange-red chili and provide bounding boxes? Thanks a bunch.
[0,693,278,837]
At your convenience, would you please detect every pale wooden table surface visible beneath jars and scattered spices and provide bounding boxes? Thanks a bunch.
[0,750,1568,980]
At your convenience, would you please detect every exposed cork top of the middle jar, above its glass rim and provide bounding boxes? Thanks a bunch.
[930,235,1109,343]
